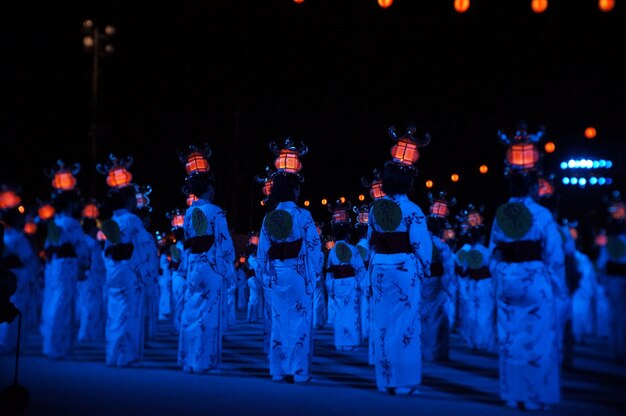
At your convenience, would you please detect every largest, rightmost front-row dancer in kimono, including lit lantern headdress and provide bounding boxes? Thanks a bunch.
[489,128,564,410]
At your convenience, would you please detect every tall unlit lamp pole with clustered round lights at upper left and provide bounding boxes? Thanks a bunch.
[83,19,116,186]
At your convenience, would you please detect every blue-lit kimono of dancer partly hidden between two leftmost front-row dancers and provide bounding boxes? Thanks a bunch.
[76,235,106,341]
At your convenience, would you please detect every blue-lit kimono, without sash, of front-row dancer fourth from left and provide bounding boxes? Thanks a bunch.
[257,201,324,377]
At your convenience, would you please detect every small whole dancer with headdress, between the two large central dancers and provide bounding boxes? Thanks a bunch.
[326,201,365,350]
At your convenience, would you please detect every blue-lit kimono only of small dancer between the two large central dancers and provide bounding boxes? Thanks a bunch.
[326,240,365,349]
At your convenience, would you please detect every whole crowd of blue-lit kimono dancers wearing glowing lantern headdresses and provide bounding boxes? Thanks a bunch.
[0,122,626,410]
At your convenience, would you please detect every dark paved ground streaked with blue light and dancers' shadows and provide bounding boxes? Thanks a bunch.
[0,314,626,416]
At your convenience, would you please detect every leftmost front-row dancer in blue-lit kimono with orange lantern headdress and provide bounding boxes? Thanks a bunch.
[41,161,90,358]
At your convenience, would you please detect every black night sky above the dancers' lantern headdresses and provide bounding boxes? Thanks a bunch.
[0,0,626,232]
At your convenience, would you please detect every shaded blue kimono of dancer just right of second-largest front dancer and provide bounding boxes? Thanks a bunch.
[420,236,454,361]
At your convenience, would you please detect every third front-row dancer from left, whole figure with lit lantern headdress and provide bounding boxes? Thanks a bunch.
[178,145,235,373]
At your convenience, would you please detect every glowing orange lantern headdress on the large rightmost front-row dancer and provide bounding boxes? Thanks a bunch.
[498,123,545,175]
